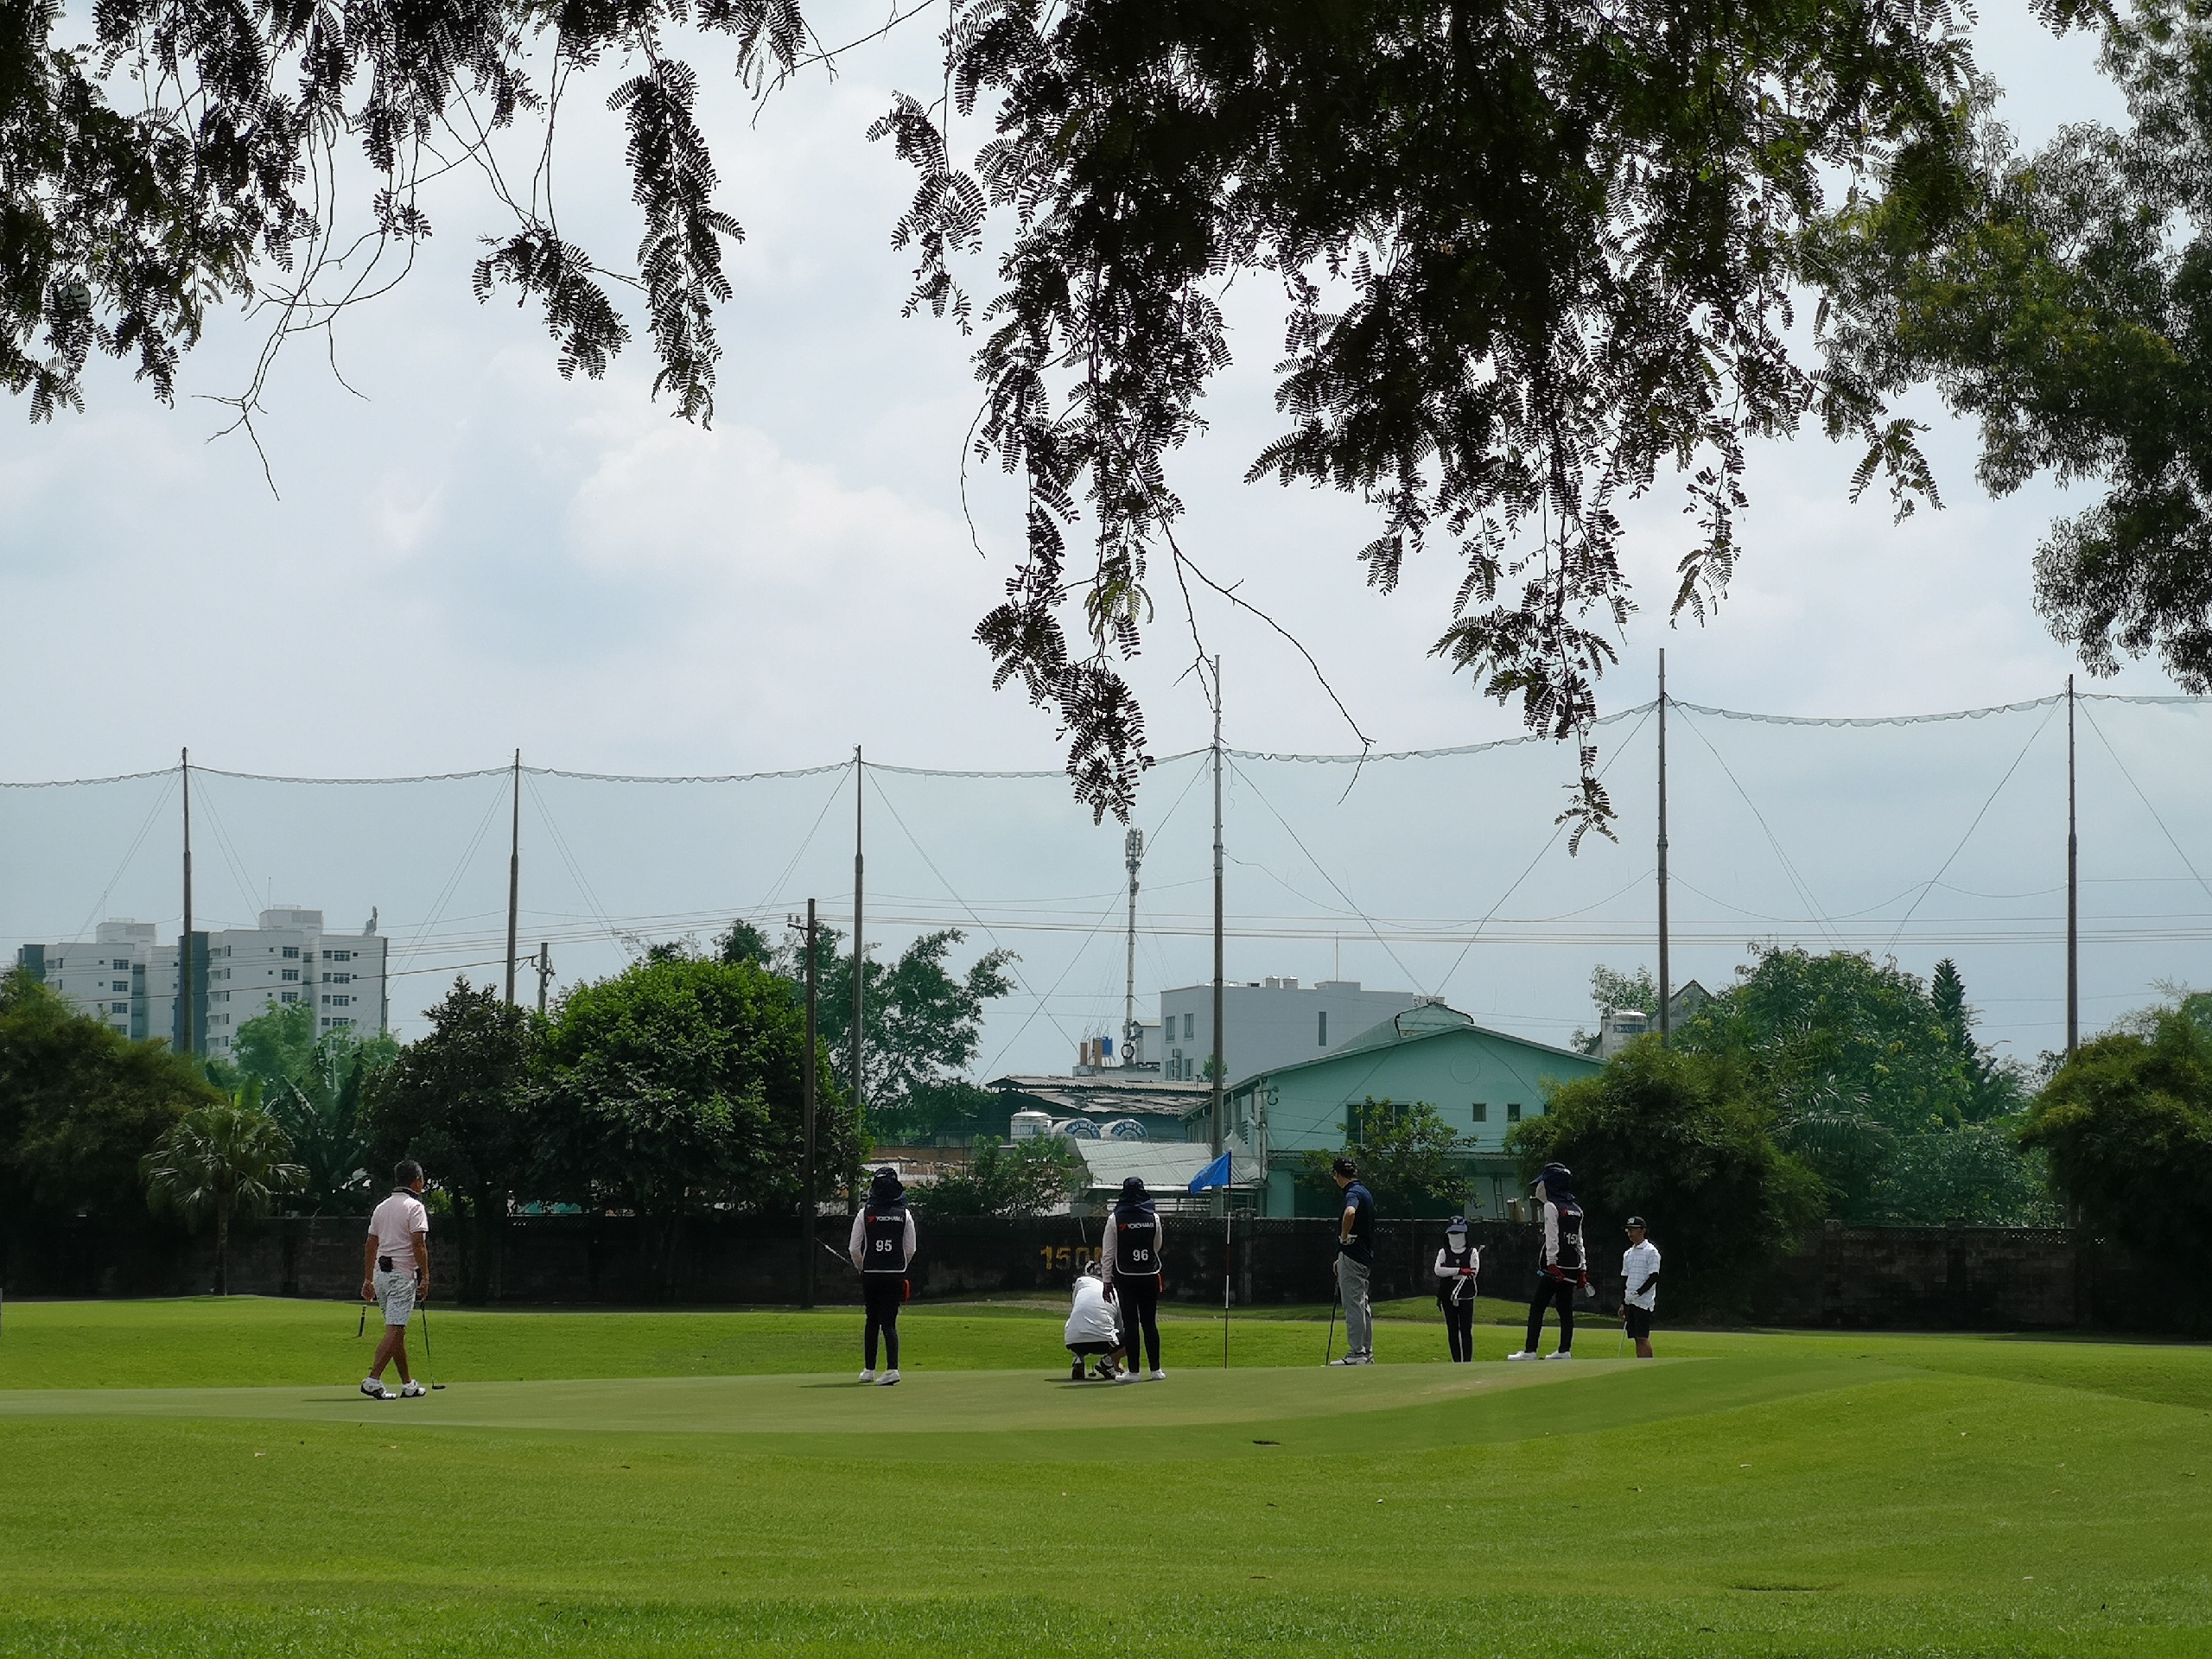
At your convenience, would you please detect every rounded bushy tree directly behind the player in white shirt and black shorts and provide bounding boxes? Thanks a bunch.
[1506,1052,1825,1310]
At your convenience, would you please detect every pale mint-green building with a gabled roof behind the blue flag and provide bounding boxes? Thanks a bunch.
[1228,1002,1601,1219]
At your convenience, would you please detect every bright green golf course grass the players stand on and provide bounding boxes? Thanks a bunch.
[0,1299,2212,1659]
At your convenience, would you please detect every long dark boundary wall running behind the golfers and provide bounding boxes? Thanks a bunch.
[0,1214,2192,1332]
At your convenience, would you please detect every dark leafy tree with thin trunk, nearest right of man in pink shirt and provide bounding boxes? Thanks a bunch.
[360,980,540,1300]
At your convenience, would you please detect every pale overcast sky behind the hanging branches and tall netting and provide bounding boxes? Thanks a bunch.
[0,4,2212,1068]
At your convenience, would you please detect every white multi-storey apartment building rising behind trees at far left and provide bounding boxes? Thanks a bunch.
[16,905,391,1059]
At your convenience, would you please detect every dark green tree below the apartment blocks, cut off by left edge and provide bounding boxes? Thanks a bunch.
[0,969,224,1221]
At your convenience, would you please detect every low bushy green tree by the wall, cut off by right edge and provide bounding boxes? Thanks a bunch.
[2022,1008,2212,1285]
